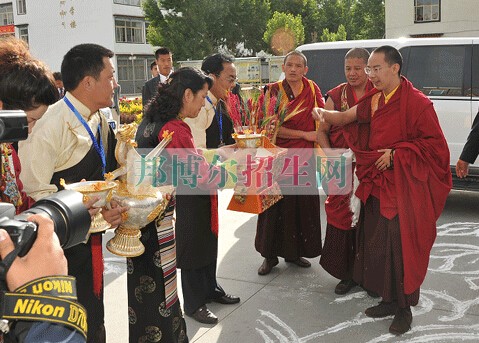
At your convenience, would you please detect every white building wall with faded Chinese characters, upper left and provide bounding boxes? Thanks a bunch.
[0,0,153,71]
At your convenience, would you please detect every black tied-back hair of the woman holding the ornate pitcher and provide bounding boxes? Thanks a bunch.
[143,67,213,123]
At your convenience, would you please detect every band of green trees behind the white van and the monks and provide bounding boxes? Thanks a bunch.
[143,0,384,60]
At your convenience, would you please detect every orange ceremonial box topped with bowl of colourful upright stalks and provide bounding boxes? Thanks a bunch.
[227,90,287,213]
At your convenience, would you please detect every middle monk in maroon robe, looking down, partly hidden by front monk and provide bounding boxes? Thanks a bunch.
[319,48,373,294]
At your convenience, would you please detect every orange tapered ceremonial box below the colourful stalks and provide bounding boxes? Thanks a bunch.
[228,135,286,214]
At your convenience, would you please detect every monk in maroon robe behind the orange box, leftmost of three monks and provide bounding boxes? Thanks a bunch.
[255,51,324,275]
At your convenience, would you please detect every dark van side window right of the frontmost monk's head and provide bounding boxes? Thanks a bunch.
[401,45,471,96]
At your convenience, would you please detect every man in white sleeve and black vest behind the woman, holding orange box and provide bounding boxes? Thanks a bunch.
[179,54,240,324]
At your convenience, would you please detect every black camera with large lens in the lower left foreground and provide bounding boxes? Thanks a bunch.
[0,190,91,256]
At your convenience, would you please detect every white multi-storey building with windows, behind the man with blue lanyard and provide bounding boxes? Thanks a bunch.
[0,0,154,95]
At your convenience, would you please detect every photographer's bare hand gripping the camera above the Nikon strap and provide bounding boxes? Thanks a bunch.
[0,214,68,291]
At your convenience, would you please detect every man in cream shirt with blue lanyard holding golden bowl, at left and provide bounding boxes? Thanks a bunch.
[19,44,126,343]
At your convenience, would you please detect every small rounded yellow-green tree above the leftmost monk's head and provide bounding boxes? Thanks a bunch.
[263,12,304,55]
